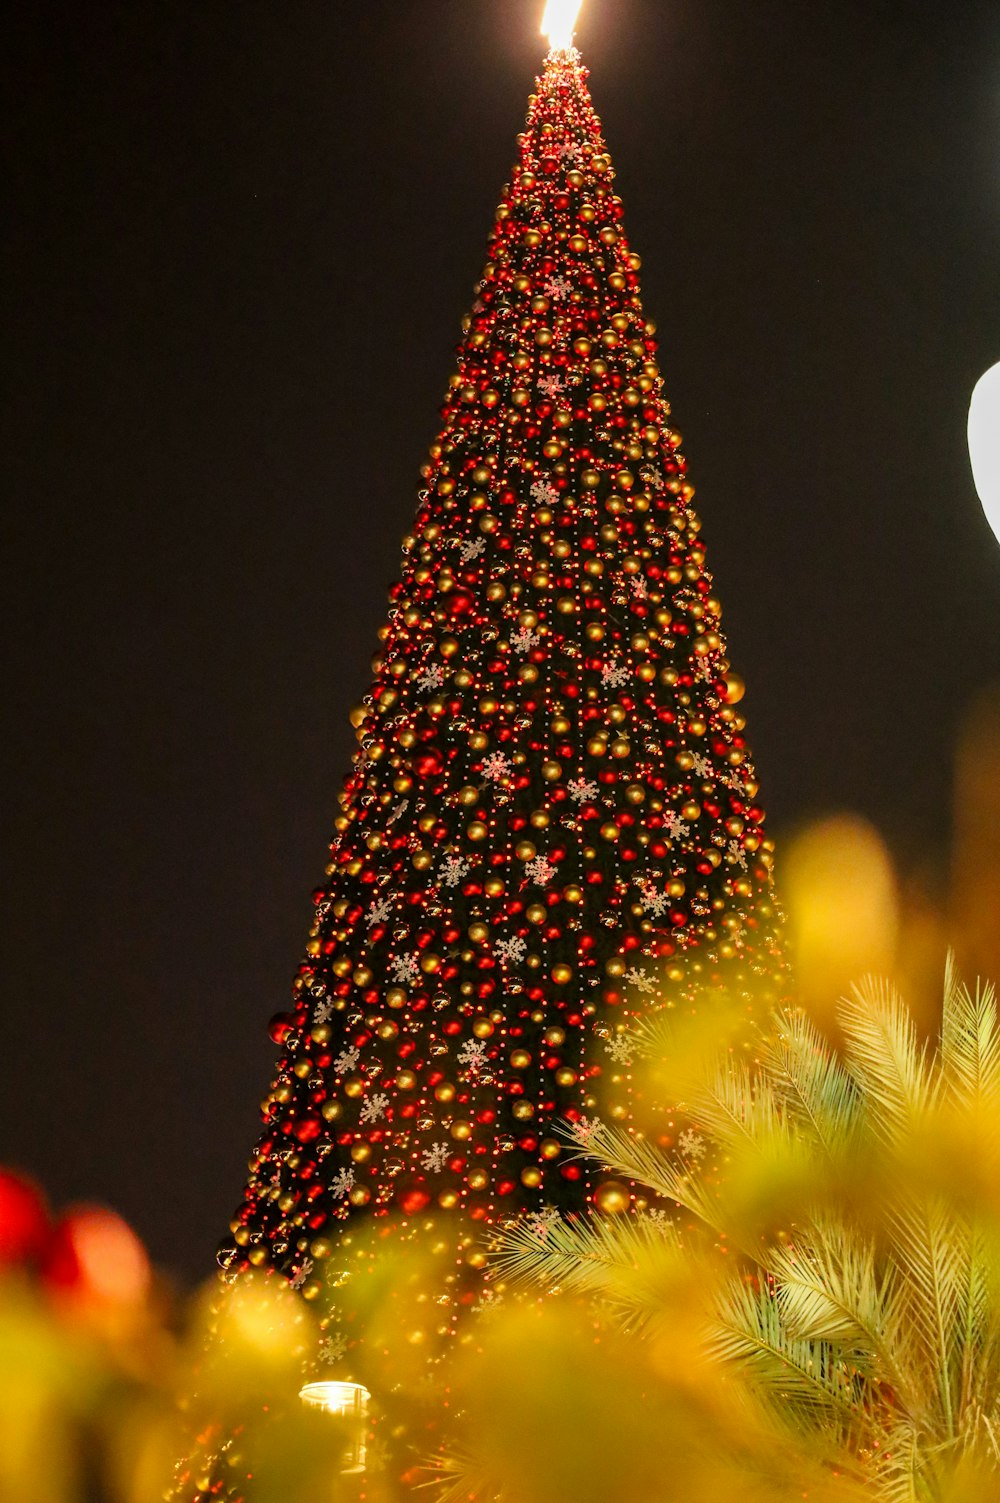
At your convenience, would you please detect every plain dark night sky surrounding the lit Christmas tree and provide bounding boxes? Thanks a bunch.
[0,0,1000,1276]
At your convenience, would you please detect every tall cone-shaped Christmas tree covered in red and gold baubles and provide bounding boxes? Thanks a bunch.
[221,23,777,1394]
